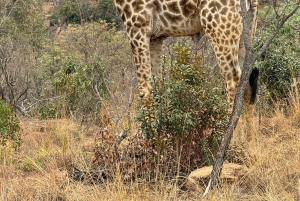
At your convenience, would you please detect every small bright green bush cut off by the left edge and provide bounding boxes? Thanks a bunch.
[0,100,22,146]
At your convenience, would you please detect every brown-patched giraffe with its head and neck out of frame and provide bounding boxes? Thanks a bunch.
[114,0,258,110]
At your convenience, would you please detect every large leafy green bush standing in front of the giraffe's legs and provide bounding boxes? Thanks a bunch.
[137,45,228,171]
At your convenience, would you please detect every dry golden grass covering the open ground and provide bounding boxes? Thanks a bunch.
[0,104,300,201]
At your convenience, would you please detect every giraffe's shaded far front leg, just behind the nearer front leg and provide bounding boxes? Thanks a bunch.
[150,38,164,79]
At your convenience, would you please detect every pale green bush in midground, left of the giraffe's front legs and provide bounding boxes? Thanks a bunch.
[39,58,108,119]
